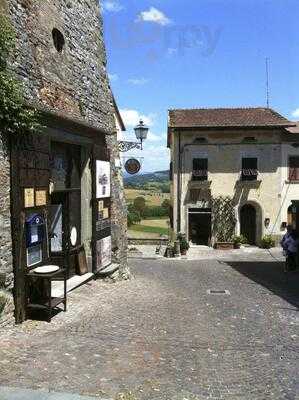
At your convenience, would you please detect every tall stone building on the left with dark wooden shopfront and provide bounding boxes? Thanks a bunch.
[0,0,129,322]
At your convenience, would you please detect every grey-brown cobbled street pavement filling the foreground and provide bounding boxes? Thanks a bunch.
[0,253,299,400]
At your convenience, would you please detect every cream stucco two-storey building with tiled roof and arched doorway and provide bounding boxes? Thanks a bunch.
[168,108,299,245]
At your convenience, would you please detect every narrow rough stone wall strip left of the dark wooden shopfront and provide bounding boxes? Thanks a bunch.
[0,141,13,326]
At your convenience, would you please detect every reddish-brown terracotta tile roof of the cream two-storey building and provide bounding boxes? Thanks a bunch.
[169,107,294,128]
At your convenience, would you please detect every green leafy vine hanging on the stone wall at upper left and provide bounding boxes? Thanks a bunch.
[0,14,40,143]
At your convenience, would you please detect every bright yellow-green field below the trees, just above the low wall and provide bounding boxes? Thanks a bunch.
[129,219,168,239]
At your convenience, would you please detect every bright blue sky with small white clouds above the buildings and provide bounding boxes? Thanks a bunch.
[102,0,299,171]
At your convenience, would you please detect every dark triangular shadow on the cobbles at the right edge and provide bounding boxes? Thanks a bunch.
[226,261,299,308]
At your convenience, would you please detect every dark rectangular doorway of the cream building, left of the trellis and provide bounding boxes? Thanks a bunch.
[188,209,212,246]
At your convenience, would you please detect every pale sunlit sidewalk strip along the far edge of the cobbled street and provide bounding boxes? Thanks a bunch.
[129,245,284,262]
